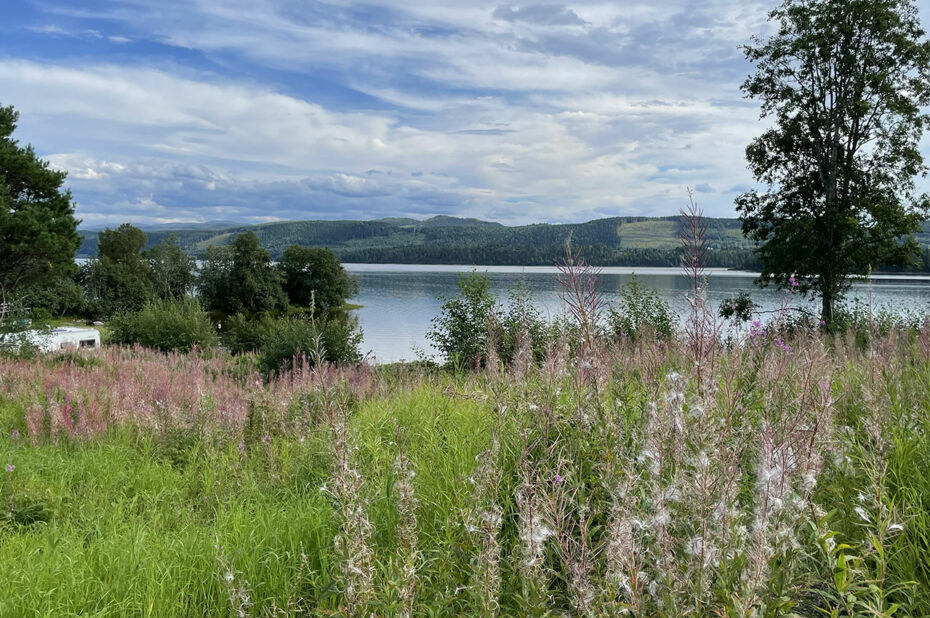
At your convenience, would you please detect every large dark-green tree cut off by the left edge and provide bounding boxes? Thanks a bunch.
[0,107,81,321]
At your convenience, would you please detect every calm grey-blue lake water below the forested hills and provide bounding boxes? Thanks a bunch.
[345,264,930,362]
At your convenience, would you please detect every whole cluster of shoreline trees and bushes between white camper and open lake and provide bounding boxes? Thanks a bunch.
[69,224,361,368]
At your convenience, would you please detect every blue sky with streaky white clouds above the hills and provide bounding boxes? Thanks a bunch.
[0,0,930,226]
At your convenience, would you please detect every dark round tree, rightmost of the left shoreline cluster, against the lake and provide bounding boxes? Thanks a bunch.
[278,245,358,312]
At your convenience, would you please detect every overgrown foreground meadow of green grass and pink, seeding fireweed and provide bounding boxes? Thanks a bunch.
[0,215,930,616]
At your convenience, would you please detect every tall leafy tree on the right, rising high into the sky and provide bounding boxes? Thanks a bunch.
[737,0,930,323]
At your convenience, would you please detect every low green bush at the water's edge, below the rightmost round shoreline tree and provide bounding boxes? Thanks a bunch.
[259,318,362,373]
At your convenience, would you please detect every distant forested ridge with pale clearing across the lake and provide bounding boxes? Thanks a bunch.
[78,215,930,272]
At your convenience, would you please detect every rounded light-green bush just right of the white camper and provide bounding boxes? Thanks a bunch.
[109,299,217,352]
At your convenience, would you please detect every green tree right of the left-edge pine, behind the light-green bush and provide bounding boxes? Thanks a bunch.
[81,223,153,317]
